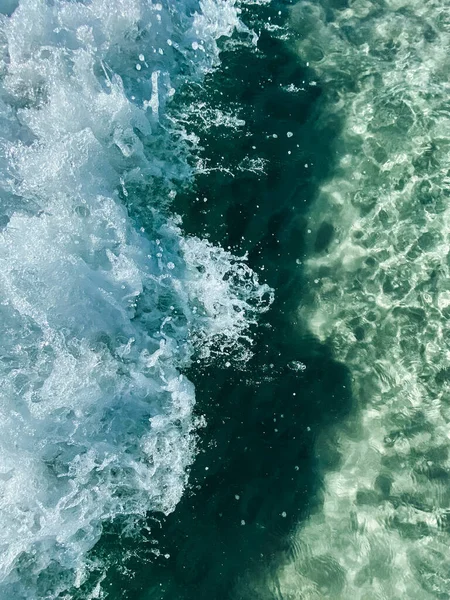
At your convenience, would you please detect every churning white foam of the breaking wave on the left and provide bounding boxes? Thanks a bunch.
[0,0,271,600]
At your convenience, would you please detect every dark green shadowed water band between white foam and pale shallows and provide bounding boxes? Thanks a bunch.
[90,3,351,600]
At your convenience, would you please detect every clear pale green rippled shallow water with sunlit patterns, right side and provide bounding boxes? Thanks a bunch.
[268,0,450,600]
